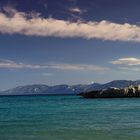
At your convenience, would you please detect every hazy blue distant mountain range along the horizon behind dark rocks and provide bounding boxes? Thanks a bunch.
[0,80,140,95]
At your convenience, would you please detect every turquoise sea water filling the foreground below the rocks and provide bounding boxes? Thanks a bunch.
[0,96,140,140]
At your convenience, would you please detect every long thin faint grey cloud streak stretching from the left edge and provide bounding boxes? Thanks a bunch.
[0,59,108,71]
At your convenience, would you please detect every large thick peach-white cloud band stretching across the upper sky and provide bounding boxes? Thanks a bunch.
[0,8,140,42]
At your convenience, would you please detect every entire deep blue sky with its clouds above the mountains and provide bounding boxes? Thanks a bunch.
[0,0,140,90]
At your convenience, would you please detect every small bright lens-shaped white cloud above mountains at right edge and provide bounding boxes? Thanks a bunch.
[111,57,140,66]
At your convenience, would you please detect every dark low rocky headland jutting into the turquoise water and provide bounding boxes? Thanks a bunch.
[80,85,140,98]
